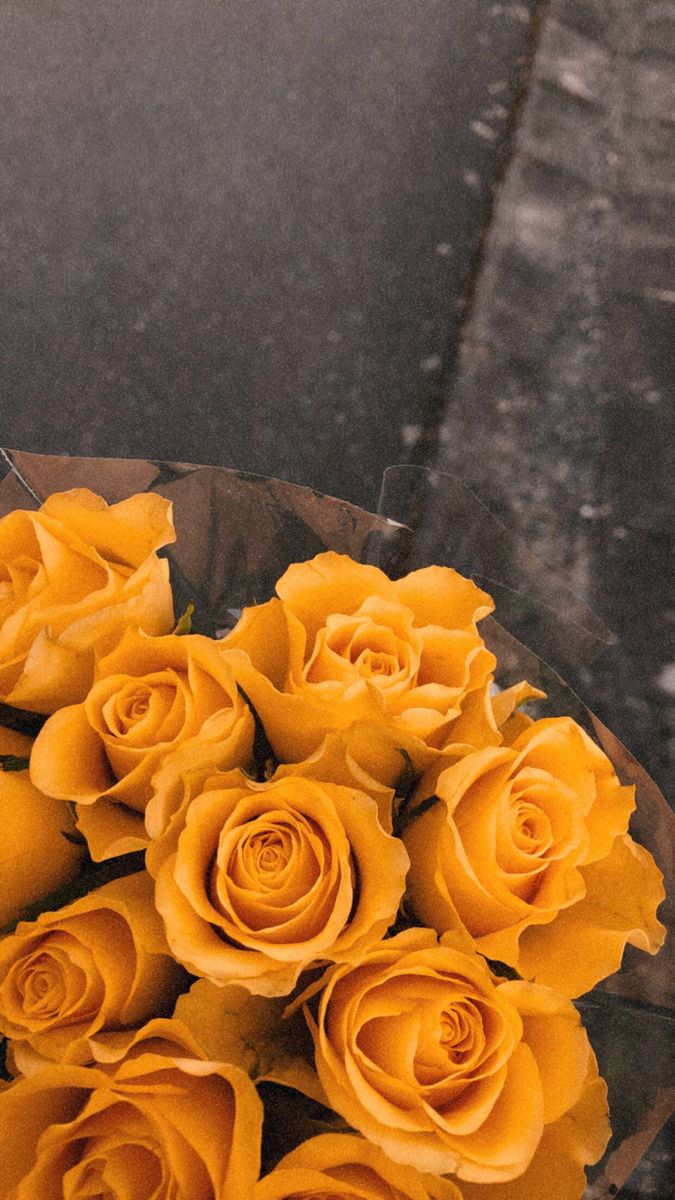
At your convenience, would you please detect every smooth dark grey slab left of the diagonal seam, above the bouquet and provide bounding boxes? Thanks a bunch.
[0,0,531,506]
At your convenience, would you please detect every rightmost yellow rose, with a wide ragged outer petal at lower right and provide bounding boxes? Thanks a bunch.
[405,716,664,997]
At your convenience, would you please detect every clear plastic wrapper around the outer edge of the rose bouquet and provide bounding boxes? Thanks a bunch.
[0,450,674,1200]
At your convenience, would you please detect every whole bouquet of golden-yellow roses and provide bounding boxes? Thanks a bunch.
[0,455,665,1200]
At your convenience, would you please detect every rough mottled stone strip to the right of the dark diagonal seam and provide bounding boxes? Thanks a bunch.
[438,0,675,806]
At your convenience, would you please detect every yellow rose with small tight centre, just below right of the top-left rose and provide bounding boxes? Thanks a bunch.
[30,630,255,859]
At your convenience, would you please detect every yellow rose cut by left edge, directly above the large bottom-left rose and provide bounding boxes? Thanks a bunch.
[0,871,185,1073]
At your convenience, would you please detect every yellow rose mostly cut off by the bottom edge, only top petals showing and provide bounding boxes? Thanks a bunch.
[255,1133,462,1200]
